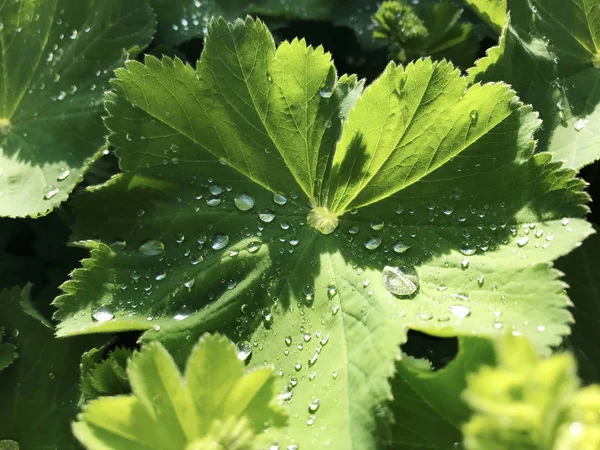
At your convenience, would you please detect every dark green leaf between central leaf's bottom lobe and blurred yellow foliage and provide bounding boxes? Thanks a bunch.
[380,338,495,450]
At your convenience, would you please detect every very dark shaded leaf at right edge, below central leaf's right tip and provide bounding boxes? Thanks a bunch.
[556,230,600,383]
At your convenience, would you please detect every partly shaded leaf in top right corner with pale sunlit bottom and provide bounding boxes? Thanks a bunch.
[469,0,600,168]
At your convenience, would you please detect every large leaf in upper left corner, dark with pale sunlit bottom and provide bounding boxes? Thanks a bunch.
[0,0,153,217]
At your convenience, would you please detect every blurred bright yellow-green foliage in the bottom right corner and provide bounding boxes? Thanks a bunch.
[463,335,600,450]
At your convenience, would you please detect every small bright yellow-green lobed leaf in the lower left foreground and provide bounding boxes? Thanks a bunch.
[73,335,285,450]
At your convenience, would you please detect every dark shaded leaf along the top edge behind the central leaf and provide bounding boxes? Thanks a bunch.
[150,0,378,47]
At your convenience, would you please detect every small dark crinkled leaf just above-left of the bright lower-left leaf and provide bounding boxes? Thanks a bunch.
[80,347,132,400]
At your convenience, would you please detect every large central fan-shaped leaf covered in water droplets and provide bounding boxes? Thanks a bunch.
[55,19,590,449]
